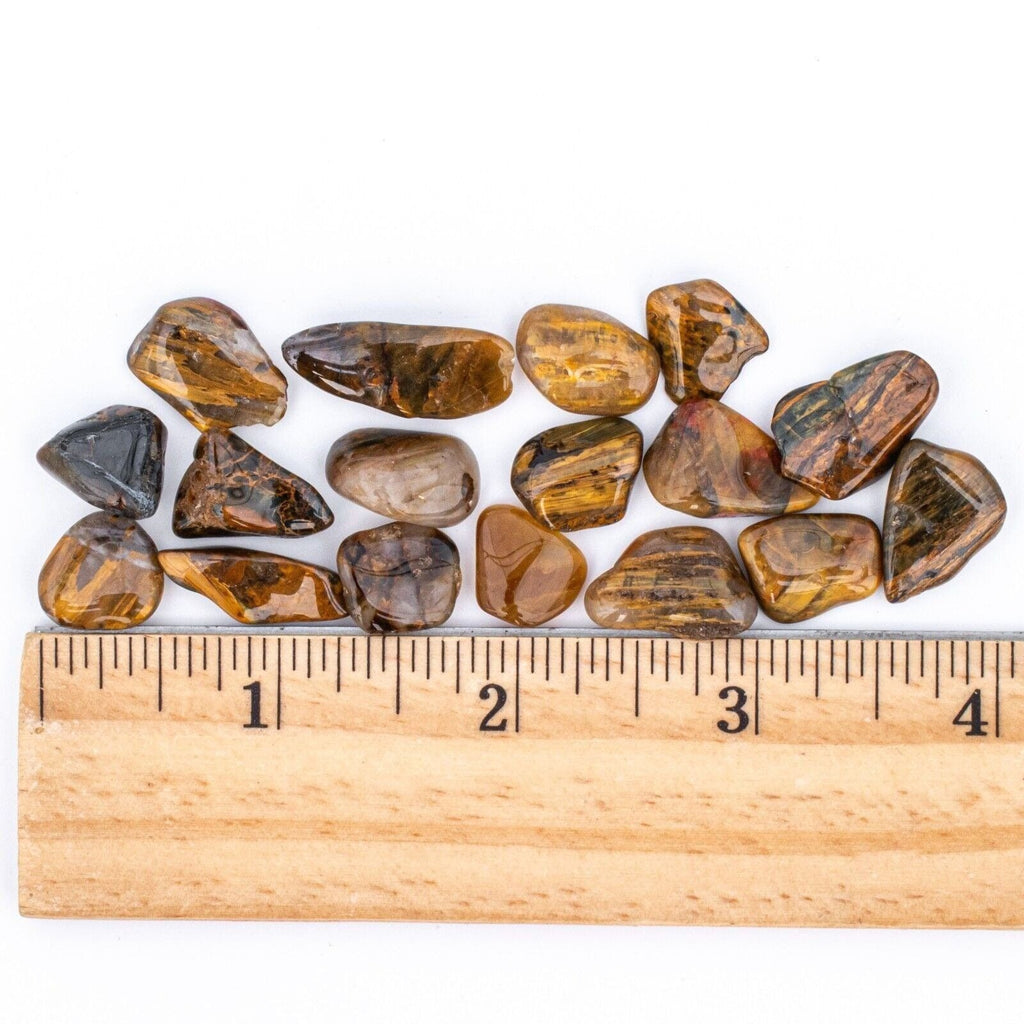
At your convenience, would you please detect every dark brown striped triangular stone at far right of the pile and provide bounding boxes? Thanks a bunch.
[882,440,1007,601]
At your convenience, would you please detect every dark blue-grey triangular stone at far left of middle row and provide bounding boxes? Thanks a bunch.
[36,406,167,519]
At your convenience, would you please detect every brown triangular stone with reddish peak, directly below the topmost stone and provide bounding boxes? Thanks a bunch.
[643,398,818,518]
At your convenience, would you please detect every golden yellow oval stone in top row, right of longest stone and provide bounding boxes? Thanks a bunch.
[516,304,658,416]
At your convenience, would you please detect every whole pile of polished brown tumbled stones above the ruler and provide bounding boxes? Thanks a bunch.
[39,281,1006,637]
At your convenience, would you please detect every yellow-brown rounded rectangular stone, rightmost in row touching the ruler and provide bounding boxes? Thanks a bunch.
[737,514,882,623]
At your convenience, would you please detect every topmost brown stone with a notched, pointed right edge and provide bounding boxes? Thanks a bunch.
[647,279,768,401]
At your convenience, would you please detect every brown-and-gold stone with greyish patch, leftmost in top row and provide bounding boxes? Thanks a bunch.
[128,298,288,430]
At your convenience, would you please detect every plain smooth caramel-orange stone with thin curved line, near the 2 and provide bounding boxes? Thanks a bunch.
[476,505,587,626]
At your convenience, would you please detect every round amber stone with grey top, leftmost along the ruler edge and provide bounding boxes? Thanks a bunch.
[39,512,164,630]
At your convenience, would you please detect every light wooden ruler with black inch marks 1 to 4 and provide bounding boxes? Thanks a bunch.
[19,631,1024,926]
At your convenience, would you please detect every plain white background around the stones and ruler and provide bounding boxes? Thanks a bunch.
[0,0,1024,1021]
